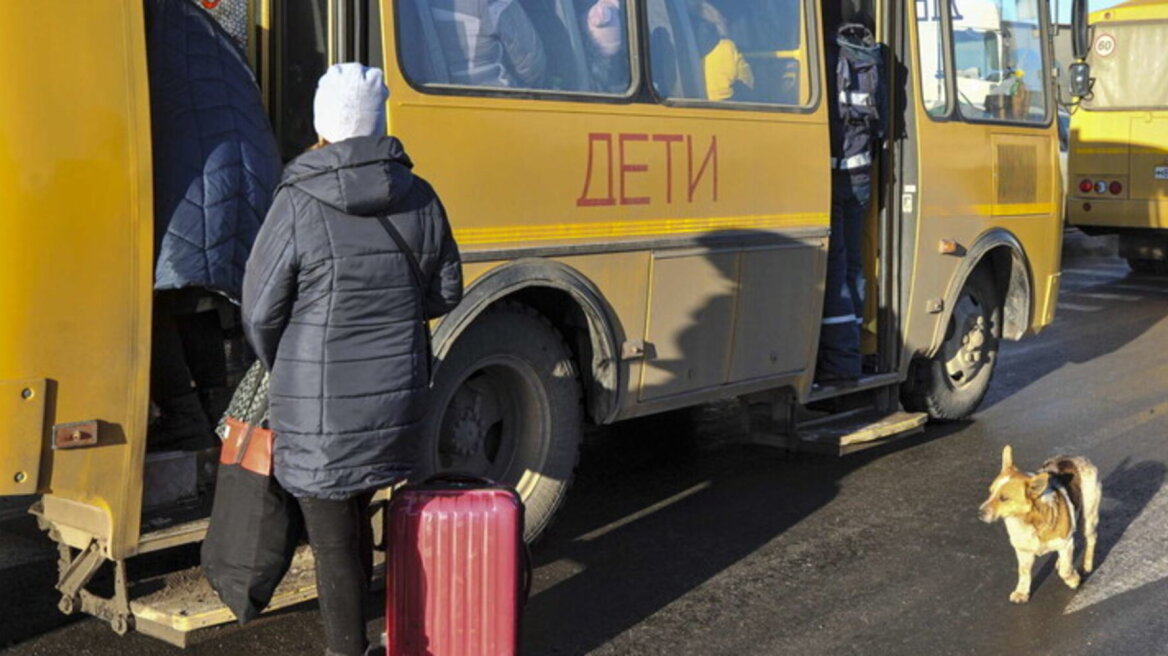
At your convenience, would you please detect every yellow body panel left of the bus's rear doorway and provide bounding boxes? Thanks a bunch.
[0,2,153,623]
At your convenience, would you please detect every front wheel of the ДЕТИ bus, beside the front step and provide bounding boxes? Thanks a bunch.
[901,267,1002,421]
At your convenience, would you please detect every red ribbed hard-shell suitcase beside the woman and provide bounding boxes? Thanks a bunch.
[385,476,530,656]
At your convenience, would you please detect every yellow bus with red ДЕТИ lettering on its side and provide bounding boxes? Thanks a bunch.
[0,0,1083,644]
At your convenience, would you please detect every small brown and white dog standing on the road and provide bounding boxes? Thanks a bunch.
[981,446,1103,603]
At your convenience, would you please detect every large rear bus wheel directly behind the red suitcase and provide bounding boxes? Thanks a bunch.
[420,302,582,542]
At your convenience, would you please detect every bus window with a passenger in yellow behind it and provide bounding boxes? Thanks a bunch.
[648,0,811,105]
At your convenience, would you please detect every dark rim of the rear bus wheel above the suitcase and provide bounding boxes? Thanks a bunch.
[429,356,550,498]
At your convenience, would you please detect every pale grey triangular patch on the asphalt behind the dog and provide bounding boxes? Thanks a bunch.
[1063,469,1168,614]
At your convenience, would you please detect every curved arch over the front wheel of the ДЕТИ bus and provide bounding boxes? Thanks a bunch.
[922,228,1034,357]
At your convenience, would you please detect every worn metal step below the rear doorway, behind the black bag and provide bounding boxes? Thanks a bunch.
[130,545,384,648]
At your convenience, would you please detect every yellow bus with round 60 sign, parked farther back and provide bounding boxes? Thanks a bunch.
[1066,0,1168,269]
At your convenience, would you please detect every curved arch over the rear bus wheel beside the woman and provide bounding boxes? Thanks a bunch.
[433,258,620,424]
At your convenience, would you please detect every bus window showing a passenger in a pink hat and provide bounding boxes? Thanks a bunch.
[397,0,632,95]
